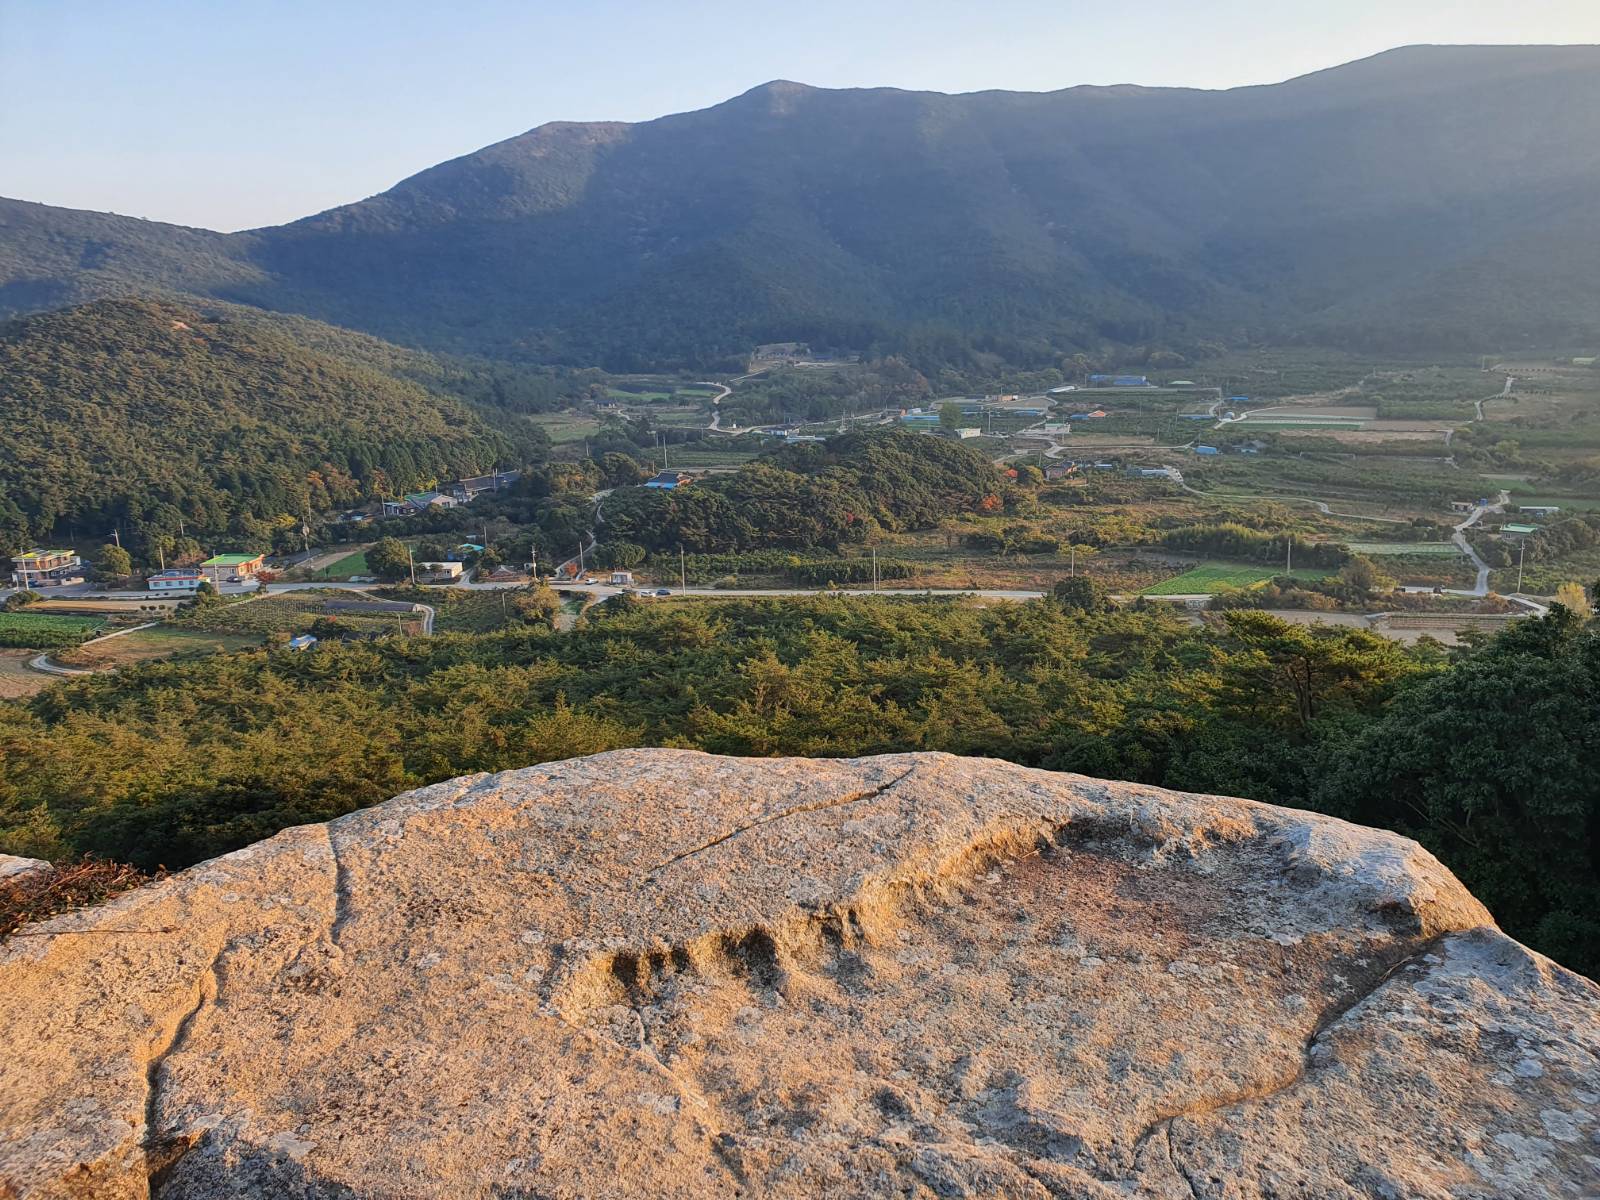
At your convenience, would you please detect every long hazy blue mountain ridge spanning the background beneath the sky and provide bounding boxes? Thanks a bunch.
[0,46,1600,366]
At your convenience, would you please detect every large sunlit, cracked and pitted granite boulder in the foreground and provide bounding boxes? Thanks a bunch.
[0,750,1600,1200]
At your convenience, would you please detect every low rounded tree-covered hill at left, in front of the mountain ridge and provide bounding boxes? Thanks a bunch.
[0,301,526,550]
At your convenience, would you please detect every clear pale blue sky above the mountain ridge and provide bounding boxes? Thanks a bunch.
[9,0,1600,229]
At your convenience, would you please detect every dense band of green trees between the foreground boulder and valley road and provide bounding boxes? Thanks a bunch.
[0,598,1600,974]
